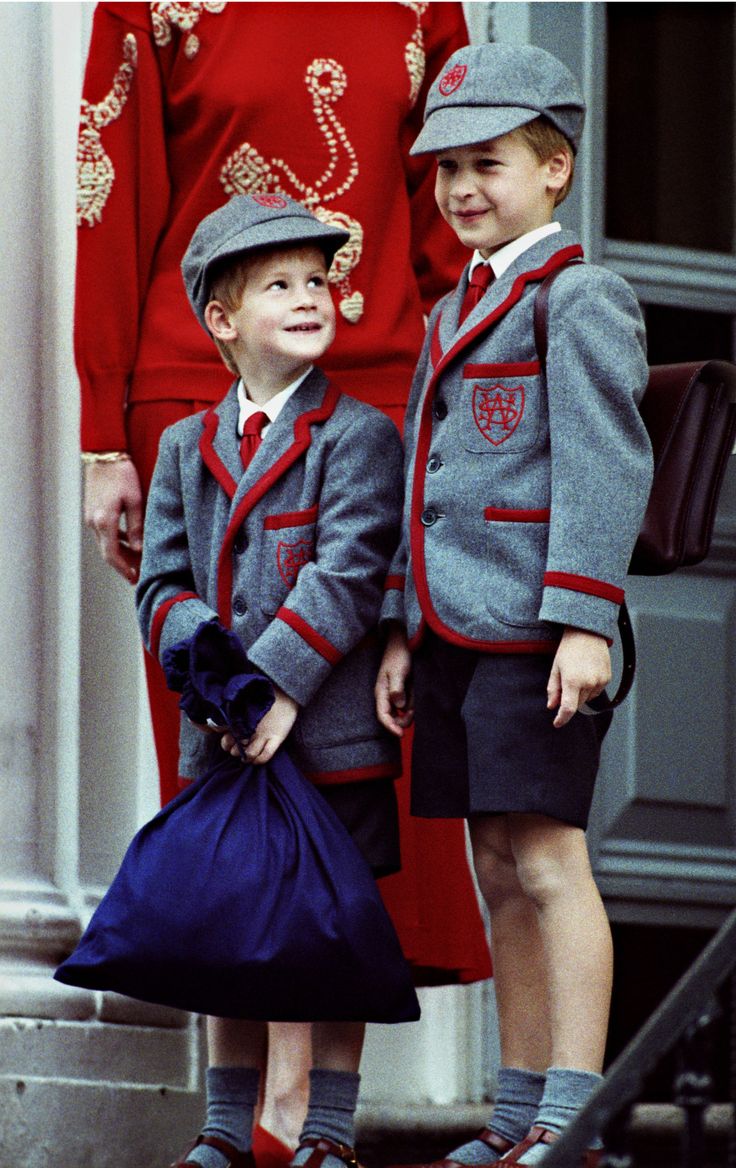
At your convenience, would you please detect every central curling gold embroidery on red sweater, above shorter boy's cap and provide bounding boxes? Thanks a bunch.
[220,57,364,325]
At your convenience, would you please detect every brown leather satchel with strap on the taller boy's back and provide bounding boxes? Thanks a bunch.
[534,260,736,712]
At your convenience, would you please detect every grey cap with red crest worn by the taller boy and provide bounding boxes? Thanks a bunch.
[410,43,585,154]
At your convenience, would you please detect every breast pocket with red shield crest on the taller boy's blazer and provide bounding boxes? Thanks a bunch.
[460,361,542,454]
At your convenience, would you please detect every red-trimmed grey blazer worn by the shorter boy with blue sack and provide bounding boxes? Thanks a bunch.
[136,369,403,783]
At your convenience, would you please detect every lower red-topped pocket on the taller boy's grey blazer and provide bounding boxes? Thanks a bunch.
[484,507,549,628]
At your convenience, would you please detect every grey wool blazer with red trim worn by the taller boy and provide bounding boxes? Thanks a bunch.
[382,231,652,653]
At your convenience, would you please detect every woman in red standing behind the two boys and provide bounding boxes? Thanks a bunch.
[75,0,491,1161]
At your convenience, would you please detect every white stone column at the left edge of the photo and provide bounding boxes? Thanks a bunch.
[0,4,84,1016]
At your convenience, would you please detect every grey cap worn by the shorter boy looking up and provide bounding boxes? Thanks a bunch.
[181,194,350,332]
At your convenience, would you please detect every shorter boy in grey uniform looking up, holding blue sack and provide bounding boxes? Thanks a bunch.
[137,194,402,1168]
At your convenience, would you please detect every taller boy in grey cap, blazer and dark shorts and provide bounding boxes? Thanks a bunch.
[376,44,652,1168]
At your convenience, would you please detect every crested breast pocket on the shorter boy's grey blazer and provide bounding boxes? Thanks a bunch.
[259,507,317,616]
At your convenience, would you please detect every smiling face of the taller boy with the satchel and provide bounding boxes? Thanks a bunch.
[435,132,570,258]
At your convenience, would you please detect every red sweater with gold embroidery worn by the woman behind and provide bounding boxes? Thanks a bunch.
[75,2,467,450]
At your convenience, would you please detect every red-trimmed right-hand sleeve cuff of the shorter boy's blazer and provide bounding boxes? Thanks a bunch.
[248,607,343,705]
